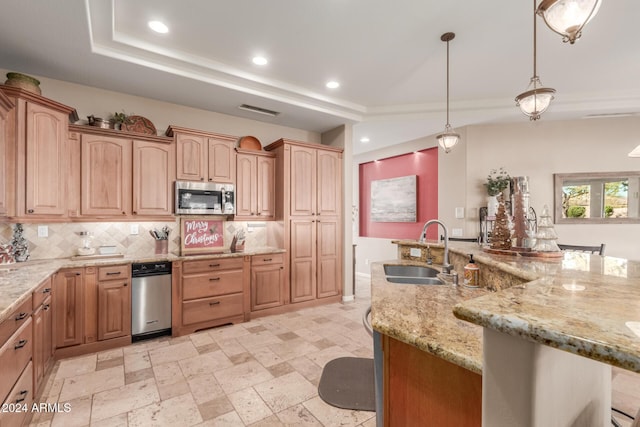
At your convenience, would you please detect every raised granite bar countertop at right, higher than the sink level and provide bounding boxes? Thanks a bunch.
[453,246,640,372]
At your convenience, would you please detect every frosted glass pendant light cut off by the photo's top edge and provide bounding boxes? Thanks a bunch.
[537,0,601,44]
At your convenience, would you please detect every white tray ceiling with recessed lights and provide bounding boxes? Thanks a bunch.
[0,0,640,154]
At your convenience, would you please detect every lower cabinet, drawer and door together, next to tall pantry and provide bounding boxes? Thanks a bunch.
[251,254,286,311]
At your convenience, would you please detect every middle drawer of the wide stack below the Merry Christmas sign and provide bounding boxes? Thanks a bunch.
[182,270,242,300]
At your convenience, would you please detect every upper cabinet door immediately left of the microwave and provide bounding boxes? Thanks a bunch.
[132,141,175,215]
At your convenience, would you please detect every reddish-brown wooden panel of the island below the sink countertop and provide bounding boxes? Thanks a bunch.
[382,335,482,427]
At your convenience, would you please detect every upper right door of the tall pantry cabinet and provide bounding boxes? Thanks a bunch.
[316,150,342,215]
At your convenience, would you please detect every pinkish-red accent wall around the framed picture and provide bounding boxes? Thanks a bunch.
[359,147,438,240]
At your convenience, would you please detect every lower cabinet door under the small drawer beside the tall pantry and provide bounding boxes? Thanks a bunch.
[251,264,284,311]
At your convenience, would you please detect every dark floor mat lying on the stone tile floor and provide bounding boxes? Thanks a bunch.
[318,357,376,411]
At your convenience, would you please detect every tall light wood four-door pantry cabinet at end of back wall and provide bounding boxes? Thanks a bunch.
[265,139,343,303]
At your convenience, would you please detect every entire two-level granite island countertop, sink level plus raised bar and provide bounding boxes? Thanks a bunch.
[371,241,640,373]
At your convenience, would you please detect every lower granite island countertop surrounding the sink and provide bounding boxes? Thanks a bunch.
[371,259,488,374]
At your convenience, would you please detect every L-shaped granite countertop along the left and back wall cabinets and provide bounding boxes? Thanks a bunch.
[0,247,285,322]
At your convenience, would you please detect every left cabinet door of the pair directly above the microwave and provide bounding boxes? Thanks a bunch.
[176,134,208,181]
